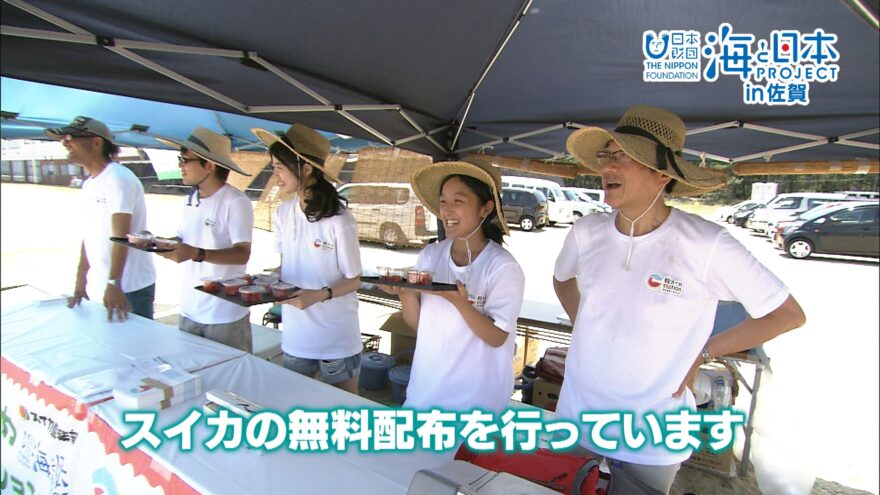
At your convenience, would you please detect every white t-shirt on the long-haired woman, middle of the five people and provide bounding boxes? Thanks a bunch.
[272,198,363,359]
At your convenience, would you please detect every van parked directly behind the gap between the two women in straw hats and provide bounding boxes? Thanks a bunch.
[339,182,437,249]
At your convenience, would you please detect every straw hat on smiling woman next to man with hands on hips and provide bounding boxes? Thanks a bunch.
[410,158,510,235]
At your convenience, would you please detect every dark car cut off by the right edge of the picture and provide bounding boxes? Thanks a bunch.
[783,202,880,259]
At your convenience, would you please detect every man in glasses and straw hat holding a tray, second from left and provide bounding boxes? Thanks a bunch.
[151,127,254,352]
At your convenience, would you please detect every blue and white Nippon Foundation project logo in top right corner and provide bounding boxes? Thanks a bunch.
[642,23,840,106]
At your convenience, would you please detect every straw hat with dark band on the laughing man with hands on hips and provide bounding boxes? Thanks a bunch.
[566,105,727,196]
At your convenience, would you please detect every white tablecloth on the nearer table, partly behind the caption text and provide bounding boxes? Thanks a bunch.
[92,355,453,495]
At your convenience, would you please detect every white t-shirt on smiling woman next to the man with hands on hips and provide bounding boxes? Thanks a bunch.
[404,239,525,412]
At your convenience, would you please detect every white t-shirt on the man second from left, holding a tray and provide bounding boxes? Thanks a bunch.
[177,184,254,325]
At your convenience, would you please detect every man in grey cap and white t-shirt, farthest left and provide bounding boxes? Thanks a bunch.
[46,117,156,321]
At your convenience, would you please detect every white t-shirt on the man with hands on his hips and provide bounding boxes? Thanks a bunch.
[554,209,789,465]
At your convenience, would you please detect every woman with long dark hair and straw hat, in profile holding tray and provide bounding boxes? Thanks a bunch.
[252,124,363,394]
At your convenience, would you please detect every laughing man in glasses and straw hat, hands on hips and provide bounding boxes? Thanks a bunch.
[553,106,805,493]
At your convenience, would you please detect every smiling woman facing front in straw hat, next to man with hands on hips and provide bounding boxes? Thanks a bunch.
[383,162,525,412]
